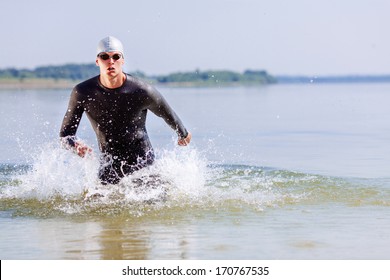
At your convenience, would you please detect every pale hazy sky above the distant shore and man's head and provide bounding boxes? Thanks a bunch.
[0,0,390,76]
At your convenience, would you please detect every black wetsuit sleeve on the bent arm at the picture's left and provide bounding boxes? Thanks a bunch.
[60,87,84,147]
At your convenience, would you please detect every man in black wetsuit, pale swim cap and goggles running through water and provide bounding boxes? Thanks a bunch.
[60,36,191,184]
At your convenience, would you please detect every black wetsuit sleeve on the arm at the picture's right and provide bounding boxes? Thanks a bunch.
[148,86,188,138]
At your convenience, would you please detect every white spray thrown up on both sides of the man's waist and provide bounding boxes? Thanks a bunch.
[3,142,207,201]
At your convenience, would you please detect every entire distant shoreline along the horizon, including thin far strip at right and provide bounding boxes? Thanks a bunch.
[0,63,390,89]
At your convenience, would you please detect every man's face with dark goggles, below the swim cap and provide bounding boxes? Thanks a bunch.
[96,52,125,77]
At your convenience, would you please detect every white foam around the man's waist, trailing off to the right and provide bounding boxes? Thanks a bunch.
[0,142,310,215]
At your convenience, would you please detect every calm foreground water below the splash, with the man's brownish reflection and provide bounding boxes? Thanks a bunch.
[0,200,390,260]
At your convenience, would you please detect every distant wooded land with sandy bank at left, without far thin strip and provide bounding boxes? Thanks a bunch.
[0,64,276,88]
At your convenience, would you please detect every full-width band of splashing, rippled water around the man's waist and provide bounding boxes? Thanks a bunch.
[0,139,390,217]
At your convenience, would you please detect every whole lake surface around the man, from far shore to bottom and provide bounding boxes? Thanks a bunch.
[0,84,390,260]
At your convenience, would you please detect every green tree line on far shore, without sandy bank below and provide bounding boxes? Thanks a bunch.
[0,63,276,85]
